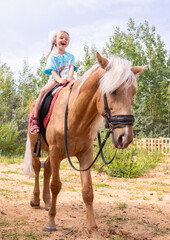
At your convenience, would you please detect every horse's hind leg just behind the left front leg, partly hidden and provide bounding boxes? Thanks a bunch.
[43,157,51,211]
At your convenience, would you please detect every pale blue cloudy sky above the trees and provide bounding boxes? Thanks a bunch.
[0,0,170,77]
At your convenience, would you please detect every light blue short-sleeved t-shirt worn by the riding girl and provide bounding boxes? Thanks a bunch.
[44,52,77,80]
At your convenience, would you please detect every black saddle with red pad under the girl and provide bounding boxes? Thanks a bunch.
[38,84,63,145]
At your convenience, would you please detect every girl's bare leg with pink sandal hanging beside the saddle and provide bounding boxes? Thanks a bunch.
[30,81,57,134]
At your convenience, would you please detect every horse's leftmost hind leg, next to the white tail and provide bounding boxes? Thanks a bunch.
[30,154,41,207]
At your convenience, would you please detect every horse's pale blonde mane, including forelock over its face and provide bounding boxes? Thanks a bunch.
[77,56,137,95]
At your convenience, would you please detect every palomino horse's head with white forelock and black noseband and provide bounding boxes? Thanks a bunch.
[97,53,147,148]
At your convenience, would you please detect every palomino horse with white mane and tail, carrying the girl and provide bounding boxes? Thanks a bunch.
[25,53,146,239]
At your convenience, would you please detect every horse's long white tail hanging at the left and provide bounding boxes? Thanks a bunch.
[24,134,34,177]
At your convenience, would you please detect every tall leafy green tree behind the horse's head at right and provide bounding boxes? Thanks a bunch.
[103,19,169,137]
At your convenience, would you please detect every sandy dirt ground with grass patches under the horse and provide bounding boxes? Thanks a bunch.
[0,159,170,240]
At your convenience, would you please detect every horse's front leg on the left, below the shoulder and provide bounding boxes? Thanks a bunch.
[44,146,61,232]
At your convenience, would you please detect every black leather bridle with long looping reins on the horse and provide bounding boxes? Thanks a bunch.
[64,83,135,172]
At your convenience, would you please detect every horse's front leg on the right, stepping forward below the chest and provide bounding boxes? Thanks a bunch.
[77,148,103,239]
